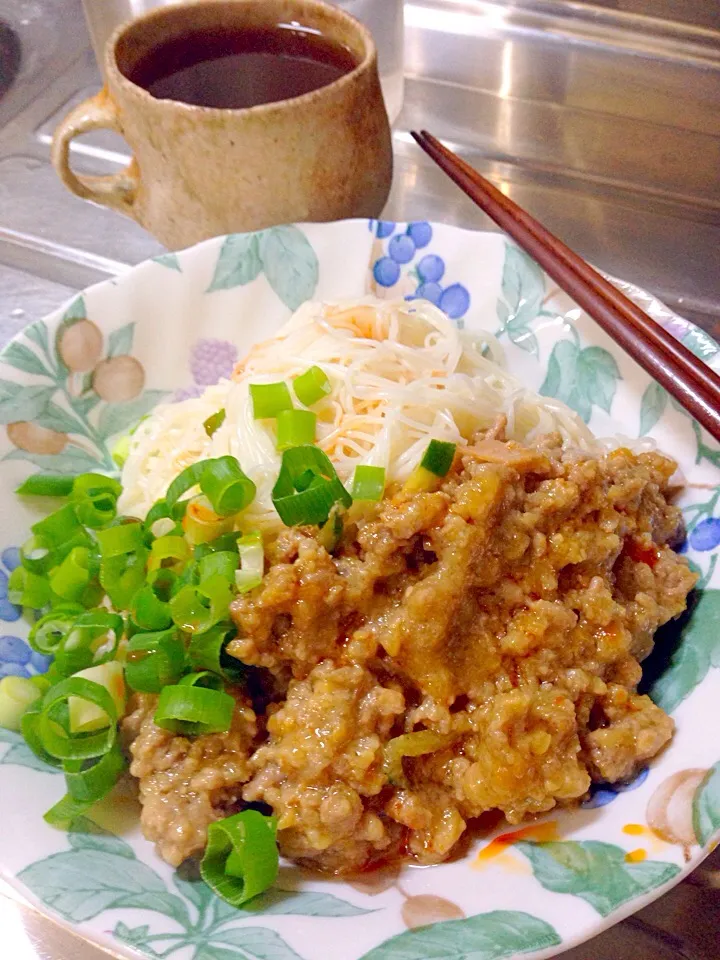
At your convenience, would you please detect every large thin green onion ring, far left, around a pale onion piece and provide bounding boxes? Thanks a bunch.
[37,676,118,760]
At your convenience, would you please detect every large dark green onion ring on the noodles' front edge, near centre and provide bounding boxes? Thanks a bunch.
[272,445,352,527]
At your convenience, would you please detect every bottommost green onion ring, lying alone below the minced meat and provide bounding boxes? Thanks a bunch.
[200,810,279,907]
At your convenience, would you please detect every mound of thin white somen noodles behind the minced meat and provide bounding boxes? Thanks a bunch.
[120,299,595,533]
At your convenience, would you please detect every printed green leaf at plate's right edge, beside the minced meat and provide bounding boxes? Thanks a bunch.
[648,590,720,713]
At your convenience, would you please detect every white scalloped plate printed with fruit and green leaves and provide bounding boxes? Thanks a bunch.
[0,221,720,960]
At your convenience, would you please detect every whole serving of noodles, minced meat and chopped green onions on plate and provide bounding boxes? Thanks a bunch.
[0,301,696,904]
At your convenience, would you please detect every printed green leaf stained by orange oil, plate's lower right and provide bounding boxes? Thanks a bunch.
[516,840,680,917]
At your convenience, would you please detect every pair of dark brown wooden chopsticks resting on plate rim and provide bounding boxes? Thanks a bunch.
[412,130,720,441]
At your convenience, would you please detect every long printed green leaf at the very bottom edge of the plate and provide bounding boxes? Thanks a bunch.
[362,910,561,960]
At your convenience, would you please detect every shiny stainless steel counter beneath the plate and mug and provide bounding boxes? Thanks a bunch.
[0,0,720,960]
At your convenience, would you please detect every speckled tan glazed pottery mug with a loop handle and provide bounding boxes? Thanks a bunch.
[52,0,392,249]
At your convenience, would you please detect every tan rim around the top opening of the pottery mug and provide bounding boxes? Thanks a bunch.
[104,0,377,115]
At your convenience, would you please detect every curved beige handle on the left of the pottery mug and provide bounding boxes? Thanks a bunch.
[51,88,140,217]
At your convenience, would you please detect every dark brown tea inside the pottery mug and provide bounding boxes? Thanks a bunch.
[126,24,357,109]
